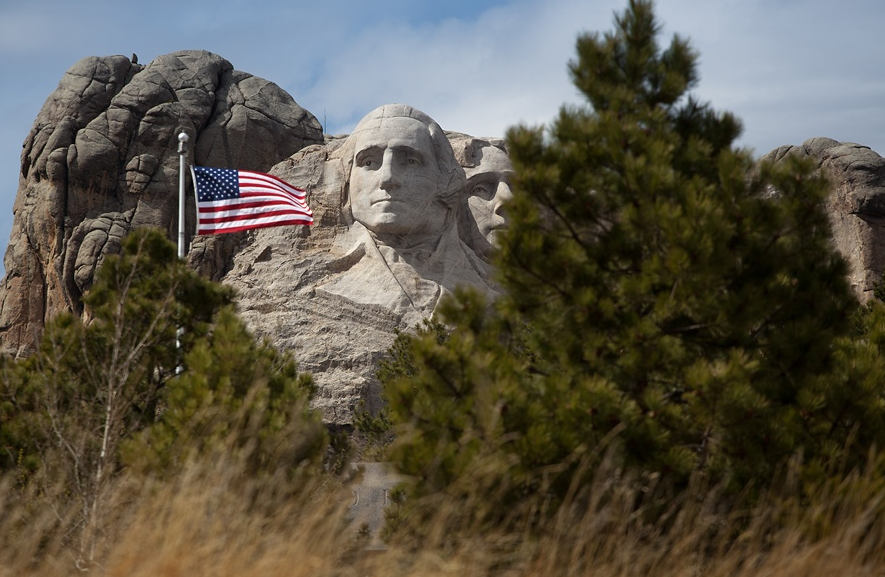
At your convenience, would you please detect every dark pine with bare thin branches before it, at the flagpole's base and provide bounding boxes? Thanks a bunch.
[4,230,232,474]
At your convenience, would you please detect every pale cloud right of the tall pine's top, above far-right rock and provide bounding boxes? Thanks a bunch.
[660,0,885,154]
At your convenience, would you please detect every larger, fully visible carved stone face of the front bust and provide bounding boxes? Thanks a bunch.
[350,116,449,235]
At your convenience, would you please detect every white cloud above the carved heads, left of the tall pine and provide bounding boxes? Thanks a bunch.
[296,0,611,135]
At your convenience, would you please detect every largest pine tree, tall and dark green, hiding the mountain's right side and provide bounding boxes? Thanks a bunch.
[387,0,885,522]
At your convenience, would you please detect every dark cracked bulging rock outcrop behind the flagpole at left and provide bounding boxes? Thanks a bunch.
[0,51,323,354]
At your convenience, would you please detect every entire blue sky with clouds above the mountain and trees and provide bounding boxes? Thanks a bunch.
[0,0,885,268]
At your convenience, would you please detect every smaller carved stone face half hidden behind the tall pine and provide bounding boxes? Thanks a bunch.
[466,146,513,253]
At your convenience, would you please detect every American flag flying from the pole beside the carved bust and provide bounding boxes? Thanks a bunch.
[191,166,313,234]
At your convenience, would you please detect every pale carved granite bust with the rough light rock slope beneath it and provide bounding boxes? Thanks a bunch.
[200,105,510,424]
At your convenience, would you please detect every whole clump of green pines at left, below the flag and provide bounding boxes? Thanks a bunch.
[0,229,326,567]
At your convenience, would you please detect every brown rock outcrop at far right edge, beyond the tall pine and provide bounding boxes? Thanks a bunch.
[763,138,885,301]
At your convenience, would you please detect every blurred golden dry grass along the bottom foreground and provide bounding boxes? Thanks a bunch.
[0,454,885,577]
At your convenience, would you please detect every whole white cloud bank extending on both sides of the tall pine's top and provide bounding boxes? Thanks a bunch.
[277,0,885,154]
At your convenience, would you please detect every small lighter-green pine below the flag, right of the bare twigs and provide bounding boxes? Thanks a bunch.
[122,307,327,491]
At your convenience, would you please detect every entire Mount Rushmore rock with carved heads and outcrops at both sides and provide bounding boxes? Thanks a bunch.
[0,51,885,424]
